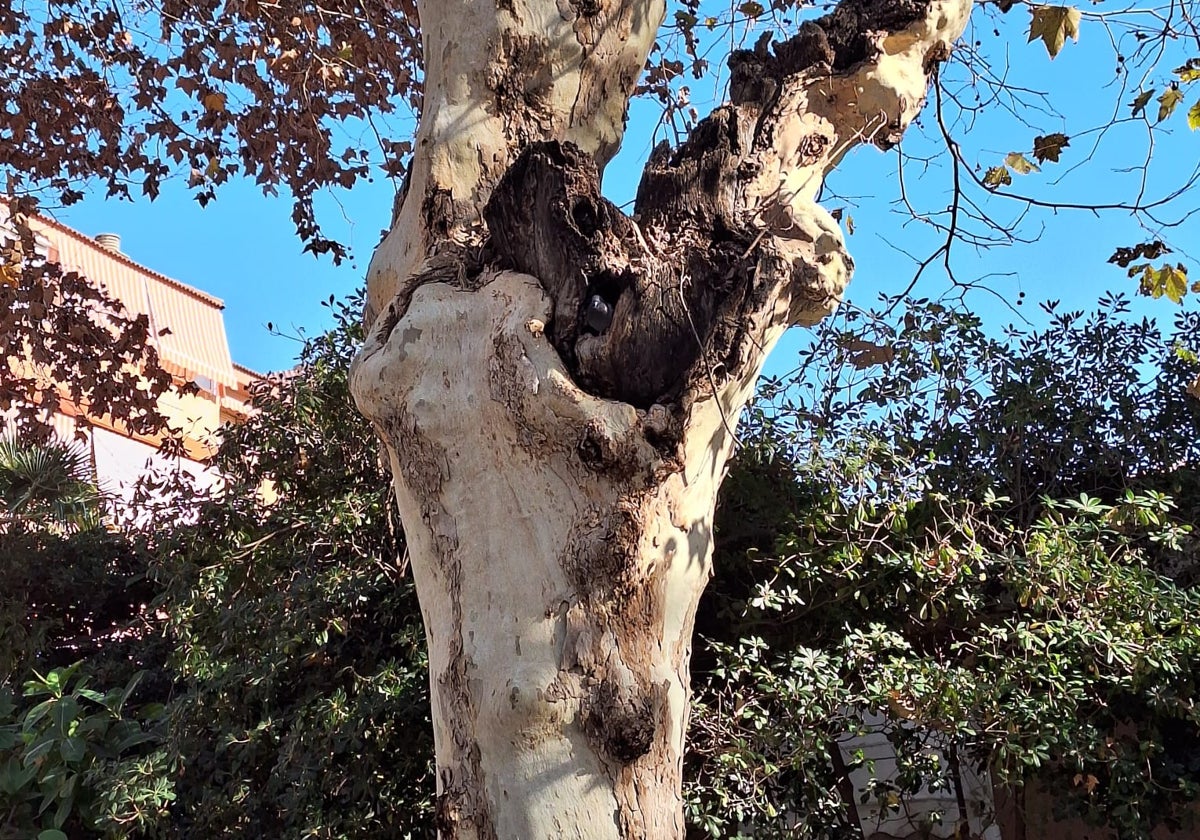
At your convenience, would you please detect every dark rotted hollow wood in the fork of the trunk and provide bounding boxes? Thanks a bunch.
[484,142,761,408]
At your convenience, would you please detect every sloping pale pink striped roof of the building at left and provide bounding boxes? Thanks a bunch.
[32,216,245,390]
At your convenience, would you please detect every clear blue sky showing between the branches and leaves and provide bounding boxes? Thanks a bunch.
[55,7,1200,371]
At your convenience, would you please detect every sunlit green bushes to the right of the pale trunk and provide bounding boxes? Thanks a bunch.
[688,294,1200,838]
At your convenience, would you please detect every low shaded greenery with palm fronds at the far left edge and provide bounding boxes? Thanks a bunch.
[0,440,173,840]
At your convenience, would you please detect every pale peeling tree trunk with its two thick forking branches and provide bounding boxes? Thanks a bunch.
[353,0,971,840]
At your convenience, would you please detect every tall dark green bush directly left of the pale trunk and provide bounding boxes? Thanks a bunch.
[144,295,434,840]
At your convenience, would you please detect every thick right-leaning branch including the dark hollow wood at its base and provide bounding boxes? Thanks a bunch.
[485,0,970,408]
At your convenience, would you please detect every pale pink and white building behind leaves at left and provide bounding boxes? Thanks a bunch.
[32,217,262,499]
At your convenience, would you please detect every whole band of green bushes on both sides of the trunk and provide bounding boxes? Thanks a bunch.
[9,291,1200,840]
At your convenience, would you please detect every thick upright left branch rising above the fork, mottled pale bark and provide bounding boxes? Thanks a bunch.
[367,0,666,322]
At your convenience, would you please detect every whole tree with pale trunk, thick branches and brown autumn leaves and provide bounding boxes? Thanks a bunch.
[0,0,1194,838]
